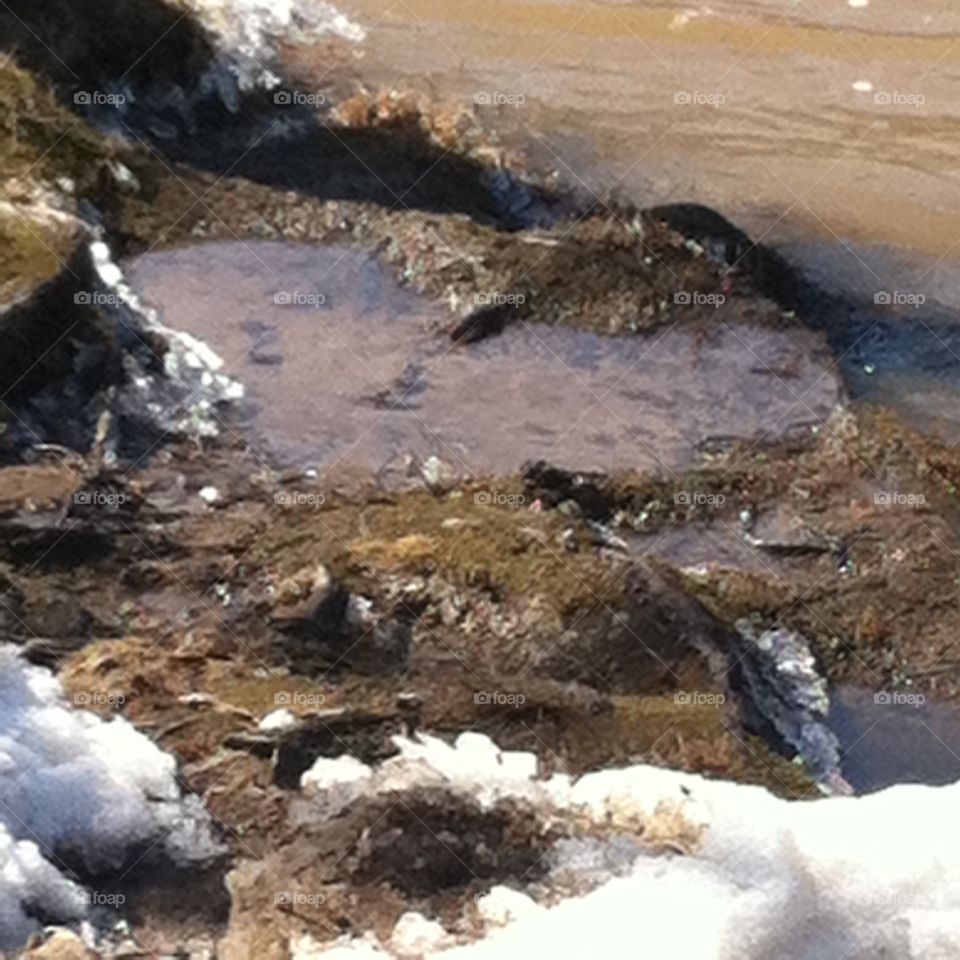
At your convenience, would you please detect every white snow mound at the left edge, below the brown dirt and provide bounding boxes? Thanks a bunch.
[0,645,218,949]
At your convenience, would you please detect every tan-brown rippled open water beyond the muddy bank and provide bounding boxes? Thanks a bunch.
[317,0,960,303]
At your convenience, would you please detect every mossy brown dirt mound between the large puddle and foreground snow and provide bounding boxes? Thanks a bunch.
[0,450,812,956]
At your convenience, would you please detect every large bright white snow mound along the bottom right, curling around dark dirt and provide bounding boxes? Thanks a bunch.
[292,734,960,960]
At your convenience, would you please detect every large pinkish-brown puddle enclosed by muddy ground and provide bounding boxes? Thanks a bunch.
[130,242,839,482]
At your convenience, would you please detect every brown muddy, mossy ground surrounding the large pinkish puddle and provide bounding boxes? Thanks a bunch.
[0,3,960,957]
